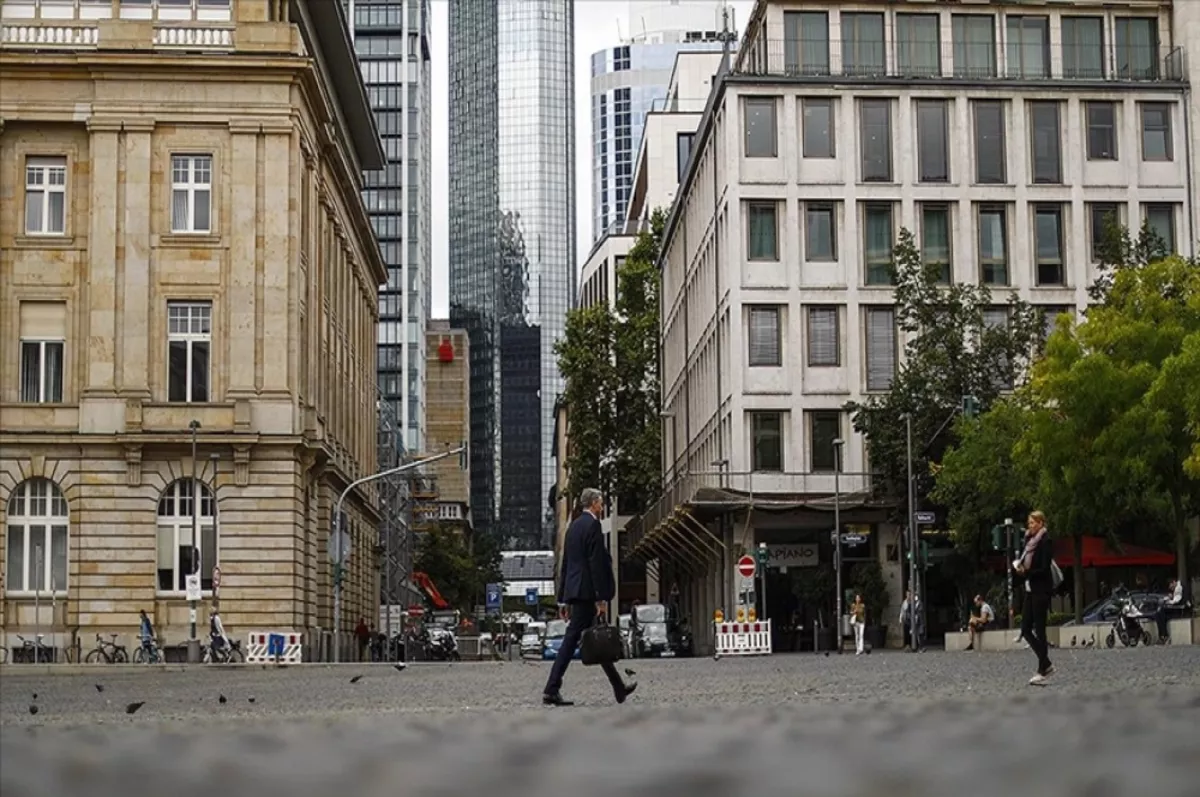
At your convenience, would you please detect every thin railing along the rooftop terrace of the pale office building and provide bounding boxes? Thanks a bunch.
[733,38,1187,83]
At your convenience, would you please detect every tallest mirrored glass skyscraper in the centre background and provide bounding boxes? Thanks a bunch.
[449,0,576,550]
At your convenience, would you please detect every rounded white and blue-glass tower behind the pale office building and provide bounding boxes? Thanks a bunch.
[592,0,737,242]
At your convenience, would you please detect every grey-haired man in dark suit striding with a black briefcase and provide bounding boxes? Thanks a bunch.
[541,487,637,706]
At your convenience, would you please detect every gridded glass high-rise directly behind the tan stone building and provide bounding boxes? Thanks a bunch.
[342,0,433,453]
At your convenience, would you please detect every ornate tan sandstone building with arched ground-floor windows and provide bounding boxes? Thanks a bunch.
[0,0,386,657]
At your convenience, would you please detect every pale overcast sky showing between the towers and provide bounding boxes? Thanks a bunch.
[430,0,754,318]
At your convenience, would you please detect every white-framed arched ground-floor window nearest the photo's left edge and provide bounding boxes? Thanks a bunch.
[5,479,67,594]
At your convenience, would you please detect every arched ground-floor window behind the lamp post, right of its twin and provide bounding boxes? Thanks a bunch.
[157,479,217,593]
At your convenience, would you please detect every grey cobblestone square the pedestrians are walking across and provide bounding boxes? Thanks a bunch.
[0,647,1200,797]
